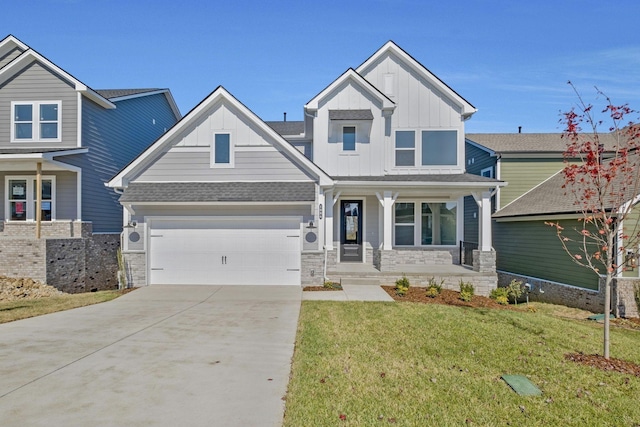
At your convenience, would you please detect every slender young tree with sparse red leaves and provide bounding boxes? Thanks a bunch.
[547,82,640,359]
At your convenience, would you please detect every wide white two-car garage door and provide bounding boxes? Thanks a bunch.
[149,218,300,285]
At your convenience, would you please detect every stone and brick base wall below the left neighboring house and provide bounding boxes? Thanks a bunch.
[0,221,120,293]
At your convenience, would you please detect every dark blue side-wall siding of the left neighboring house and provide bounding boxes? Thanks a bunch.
[64,94,177,232]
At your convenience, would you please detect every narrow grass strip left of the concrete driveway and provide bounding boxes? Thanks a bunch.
[0,291,122,323]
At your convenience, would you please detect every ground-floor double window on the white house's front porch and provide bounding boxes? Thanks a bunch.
[394,201,458,246]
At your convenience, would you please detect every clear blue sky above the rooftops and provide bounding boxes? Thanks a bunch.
[0,0,640,132]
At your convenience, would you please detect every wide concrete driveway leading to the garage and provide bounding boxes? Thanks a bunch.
[0,286,302,426]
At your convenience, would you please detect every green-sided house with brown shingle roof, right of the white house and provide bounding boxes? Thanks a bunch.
[465,133,638,315]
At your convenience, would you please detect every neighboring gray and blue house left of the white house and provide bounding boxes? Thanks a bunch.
[0,35,181,291]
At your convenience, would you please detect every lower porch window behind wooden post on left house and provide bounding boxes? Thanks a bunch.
[5,176,55,221]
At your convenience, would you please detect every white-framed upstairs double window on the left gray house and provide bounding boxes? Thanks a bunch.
[11,101,62,142]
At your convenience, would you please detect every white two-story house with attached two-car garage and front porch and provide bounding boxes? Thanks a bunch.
[109,42,502,293]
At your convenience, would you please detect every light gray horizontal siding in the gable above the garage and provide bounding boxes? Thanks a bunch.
[135,147,310,182]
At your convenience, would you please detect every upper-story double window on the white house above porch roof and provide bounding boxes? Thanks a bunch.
[395,130,458,167]
